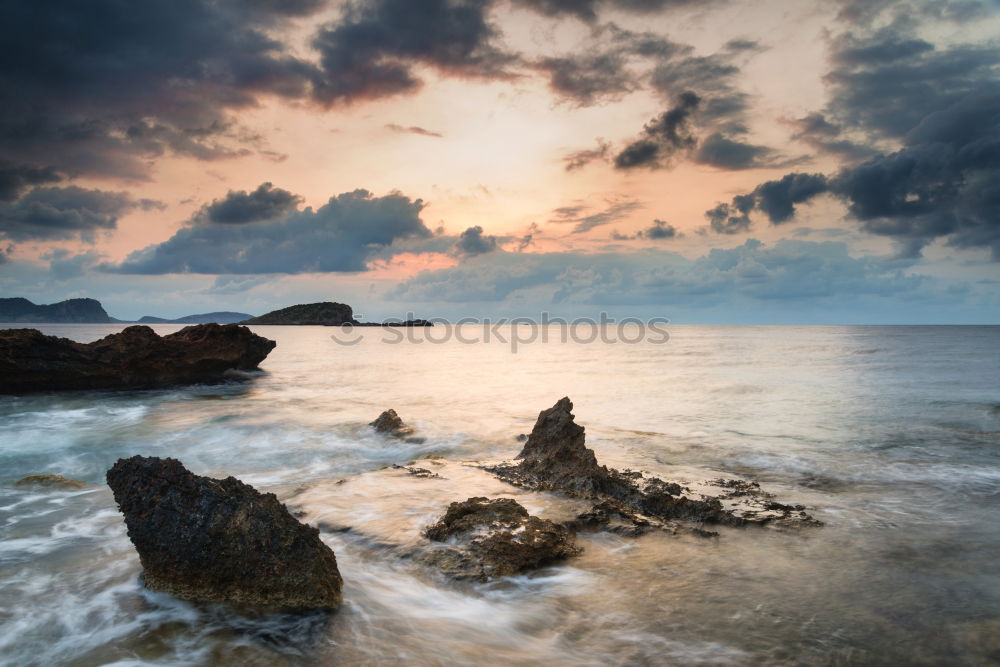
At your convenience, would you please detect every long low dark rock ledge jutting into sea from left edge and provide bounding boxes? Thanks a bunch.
[0,324,276,394]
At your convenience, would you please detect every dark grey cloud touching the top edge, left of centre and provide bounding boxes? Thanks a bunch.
[312,0,517,104]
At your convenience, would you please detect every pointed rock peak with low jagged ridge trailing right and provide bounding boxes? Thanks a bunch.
[487,398,813,526]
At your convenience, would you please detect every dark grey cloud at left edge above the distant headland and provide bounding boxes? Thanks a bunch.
[0,185,148,243]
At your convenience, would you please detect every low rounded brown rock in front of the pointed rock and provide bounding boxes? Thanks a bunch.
[422,497,581,581]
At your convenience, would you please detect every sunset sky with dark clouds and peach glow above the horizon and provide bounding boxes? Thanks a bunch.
[0,0,1000,324]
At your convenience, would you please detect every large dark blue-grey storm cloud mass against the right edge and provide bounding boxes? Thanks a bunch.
[706,20,1000,261]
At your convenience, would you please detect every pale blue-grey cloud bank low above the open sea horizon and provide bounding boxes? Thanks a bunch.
[388,239,926,308]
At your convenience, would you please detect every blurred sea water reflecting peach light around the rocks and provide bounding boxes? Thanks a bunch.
[0,325,1000,666]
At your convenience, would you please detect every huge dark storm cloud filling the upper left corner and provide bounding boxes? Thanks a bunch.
[0,0,318,184]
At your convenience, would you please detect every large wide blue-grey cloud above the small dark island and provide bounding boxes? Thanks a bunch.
[103,190,431,275]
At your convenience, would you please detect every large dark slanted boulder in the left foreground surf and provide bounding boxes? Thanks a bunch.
[107,456,343,610]
